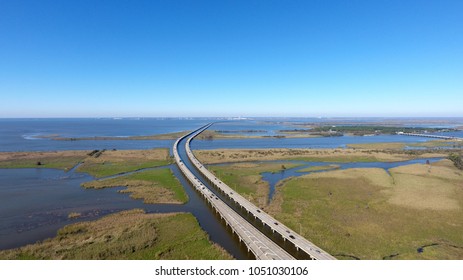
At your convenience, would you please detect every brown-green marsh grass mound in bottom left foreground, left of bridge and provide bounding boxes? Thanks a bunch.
[0,209,232,260]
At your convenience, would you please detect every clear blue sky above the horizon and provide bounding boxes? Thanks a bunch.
[0,0,463,117]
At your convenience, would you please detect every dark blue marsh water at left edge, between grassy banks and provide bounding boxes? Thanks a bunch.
[0,168,177,249]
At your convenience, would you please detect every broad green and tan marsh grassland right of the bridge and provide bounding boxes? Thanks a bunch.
[204,150,463,259]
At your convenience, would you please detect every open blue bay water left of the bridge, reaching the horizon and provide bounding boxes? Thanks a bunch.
[0,118,210,152]
